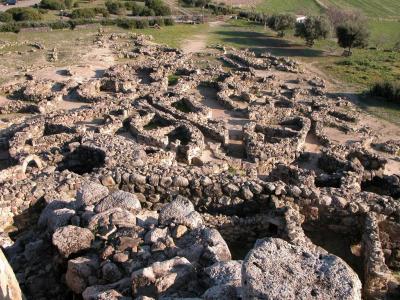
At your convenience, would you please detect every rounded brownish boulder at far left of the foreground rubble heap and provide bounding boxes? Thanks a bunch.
[53,225,94,257]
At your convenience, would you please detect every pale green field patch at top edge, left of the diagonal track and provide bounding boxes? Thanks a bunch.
[256,0,321,14]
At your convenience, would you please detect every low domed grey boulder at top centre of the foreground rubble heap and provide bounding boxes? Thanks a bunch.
[94,191,142,212]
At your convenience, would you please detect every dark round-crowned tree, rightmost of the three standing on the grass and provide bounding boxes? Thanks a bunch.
[336,22,370,55]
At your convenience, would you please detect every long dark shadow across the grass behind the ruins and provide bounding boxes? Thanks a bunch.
[215,26,324,57]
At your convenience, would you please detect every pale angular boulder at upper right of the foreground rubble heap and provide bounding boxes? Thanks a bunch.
[159,196,203,229]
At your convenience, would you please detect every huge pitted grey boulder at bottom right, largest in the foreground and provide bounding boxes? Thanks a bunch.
[242,238,361,300]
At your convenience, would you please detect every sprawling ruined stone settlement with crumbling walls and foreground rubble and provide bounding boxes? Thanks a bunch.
[0,34,400,300]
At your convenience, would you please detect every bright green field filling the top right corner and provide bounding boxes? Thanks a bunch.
[323,0,400,18]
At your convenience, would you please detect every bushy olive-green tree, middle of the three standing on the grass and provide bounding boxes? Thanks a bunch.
[295,16,331,47]
